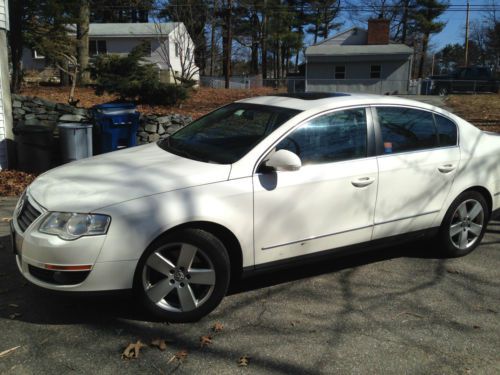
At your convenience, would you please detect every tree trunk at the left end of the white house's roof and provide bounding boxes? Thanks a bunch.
[76,0,90,85]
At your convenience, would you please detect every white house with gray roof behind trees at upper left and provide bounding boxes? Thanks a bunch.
[22,22,199,82]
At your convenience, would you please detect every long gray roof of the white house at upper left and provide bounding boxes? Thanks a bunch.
[89,22,180,37]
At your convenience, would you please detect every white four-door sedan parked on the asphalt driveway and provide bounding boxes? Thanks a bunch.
[12,94,500,322]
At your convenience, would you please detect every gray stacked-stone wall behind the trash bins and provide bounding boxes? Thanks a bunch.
[12,95,193,144]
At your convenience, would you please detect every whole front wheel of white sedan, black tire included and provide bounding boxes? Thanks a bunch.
[134,228,230,323]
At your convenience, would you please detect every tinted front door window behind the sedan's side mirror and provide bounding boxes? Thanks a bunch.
[276,108,367,165]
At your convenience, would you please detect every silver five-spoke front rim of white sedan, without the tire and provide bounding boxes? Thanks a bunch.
[142,243,216,312]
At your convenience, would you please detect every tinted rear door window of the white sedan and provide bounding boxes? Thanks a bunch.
[377,107,438,154]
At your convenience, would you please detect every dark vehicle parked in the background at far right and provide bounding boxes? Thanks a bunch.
[429,66,499,95]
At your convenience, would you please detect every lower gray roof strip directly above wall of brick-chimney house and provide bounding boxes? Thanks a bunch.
[306,44,413,56]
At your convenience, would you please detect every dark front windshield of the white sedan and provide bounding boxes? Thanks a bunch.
[158,103,300,164]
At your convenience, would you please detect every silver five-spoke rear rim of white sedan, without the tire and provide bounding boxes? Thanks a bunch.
[449,199,485,250]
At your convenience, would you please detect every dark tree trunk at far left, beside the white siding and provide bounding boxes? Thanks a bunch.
[9,0,24,93]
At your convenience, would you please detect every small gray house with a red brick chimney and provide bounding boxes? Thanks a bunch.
[305,19,413,94]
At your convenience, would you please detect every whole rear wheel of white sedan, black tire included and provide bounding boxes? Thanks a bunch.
[439,191,489,257]
